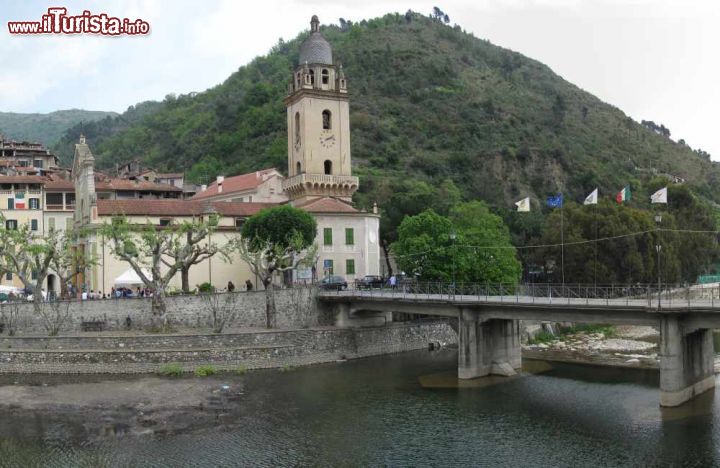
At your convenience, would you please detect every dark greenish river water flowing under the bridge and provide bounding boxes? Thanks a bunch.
[0,350,720,467]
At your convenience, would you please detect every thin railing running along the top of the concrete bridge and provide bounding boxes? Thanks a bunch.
[324,281,720,308]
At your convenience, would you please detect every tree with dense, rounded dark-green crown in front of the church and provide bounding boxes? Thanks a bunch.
[236,205,317,328]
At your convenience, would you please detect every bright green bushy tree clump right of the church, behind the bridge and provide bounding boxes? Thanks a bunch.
[392,202,521,284]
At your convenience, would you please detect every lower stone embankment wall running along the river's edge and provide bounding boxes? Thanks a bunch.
[0,319,457,374]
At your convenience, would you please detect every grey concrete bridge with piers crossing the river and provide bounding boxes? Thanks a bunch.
[319,285,720,406]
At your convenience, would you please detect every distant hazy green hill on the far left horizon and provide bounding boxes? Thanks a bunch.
[0,109,118,146]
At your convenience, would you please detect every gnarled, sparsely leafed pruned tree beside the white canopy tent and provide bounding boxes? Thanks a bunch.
[100,214,226,329]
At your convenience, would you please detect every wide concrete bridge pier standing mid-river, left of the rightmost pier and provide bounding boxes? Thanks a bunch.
[458,310,522,379]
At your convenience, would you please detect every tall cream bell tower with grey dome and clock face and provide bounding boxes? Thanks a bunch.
[283,16,358,202]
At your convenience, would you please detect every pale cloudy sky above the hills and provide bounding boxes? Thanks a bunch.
[0,0,720,160]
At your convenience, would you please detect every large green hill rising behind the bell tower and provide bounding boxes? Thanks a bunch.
[52,14,720,207]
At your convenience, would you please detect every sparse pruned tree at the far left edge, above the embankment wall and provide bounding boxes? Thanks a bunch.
[0,217,70,314]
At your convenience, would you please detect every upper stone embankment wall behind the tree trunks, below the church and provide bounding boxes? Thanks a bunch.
[0,288,326,335]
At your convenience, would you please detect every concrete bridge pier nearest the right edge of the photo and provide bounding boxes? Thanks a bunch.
[660,316,715,406]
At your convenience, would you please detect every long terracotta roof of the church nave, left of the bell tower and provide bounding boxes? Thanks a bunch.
[97,199,276,216]
